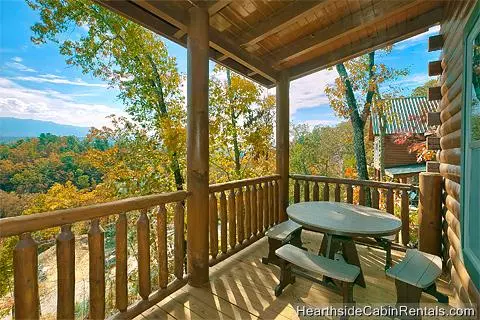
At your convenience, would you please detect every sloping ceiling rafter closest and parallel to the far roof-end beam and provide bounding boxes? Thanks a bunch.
[268,0,418,64]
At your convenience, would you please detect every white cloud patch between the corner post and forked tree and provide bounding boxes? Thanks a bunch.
[290,70,338,114]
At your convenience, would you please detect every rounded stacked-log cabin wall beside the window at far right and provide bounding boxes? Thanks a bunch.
[438,1,480,306]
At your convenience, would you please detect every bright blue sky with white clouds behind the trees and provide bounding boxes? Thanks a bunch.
[0,0,439,127]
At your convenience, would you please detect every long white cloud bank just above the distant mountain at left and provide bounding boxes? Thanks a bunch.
[0,78,126,127]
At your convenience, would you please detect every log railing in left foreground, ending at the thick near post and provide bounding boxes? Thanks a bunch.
[0,191,188,319]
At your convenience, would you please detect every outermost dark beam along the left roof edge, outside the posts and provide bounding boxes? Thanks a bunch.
[94,0,275,87]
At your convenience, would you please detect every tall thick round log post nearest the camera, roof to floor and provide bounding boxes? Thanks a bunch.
[187,6,209,287]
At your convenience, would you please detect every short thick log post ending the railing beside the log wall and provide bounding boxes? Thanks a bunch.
[418,172,442,256]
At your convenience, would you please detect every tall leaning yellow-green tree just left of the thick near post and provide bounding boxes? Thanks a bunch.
[28,0,186,189]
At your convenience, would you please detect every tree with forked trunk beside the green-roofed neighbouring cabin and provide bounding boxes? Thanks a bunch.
[325,48,408,184]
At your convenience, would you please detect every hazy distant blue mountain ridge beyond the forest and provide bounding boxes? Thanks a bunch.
[0,117,90,140]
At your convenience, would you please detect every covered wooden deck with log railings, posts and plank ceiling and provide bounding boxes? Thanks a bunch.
[0,0,473,319]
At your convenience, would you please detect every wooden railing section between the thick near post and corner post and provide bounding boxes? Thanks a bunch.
[209,175,280,266]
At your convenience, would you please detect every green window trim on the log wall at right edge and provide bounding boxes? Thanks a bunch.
[460,2,480,288]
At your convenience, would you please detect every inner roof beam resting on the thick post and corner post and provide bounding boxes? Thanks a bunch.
[131,0,277,82]
